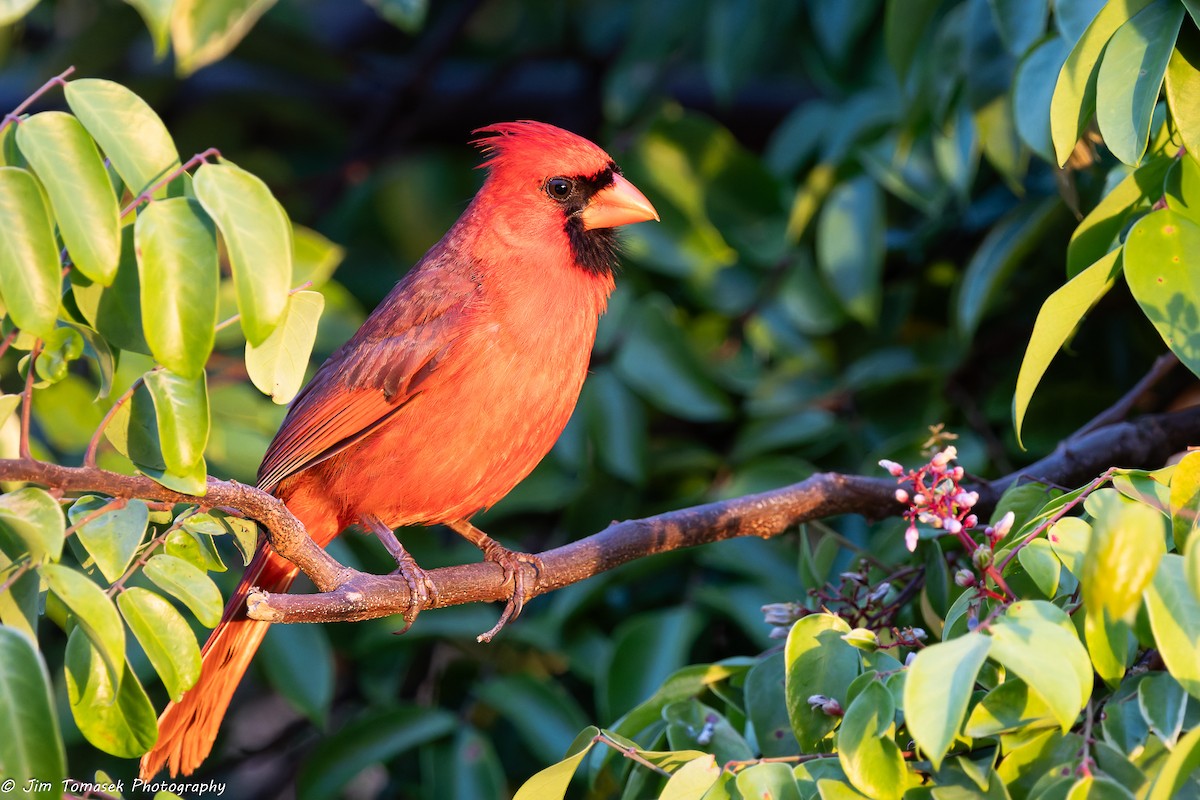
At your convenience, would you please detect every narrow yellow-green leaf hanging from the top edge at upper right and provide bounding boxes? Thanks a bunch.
[1050,0,1152,167]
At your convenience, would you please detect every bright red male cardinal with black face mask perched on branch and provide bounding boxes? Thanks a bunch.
[142,122,659,778]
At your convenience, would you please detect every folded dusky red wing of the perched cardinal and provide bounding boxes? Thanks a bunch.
[258,268,474,492]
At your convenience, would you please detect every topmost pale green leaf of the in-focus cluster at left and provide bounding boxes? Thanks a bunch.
[65,78,180,198]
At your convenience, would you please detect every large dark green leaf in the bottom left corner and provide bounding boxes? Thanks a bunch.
[0,626,67,800]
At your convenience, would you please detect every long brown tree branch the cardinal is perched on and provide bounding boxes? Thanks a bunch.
[0,408,1200,622]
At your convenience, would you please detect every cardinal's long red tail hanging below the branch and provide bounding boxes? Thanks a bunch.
[142,546,299,781]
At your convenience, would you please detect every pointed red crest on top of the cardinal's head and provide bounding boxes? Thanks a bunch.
[472,120,612,178]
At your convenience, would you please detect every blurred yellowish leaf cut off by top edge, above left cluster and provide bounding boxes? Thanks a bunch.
[170,0,275,77]
